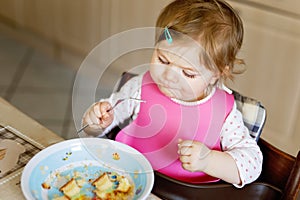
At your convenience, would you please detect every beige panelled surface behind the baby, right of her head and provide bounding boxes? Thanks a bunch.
[230,0,300,155]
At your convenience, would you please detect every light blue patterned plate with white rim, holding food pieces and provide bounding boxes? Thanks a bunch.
[21,138,154,200]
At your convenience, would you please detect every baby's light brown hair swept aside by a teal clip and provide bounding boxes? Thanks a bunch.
[155,0,244,80]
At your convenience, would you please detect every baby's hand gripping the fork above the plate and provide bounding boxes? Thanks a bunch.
[83,102,114,132]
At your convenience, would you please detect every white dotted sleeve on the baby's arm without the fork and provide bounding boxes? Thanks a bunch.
[221,104,263,188]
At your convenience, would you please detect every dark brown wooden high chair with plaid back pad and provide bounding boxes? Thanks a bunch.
[107,72,300,200]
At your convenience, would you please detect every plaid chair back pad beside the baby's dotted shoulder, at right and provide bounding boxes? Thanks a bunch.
[233,91,266,141]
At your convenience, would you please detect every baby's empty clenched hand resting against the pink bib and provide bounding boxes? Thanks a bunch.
[178,139,211,172]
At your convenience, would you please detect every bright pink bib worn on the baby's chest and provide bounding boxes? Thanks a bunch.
[116,72,234,183]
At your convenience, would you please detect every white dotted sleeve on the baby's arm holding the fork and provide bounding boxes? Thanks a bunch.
[99,75,143,137]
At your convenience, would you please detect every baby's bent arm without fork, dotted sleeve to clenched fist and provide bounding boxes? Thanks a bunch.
[179,106,262,187]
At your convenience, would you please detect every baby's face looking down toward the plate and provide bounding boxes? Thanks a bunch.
[150,41,218,101]
